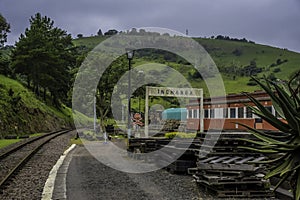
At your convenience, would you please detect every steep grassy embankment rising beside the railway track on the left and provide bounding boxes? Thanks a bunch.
[0,75,72,138]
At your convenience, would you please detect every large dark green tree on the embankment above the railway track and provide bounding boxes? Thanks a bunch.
[12,13,75,106]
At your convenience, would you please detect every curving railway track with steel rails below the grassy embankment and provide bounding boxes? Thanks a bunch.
[0,130,70,191]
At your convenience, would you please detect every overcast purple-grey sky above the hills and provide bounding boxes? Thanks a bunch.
[0,0,300,52]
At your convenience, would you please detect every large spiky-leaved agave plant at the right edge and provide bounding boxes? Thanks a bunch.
[241,71,300,200]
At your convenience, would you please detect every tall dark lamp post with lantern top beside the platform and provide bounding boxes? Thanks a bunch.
[126,49,134,139]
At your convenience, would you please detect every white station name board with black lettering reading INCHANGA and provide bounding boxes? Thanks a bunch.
[148,87,202,98]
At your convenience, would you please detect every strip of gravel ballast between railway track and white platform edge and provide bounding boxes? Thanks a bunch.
[0,131,75,200]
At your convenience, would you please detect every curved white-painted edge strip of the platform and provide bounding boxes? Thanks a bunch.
[41,144,76,200]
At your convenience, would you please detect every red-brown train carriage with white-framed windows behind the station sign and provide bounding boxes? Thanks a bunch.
[186,91,277,131]
